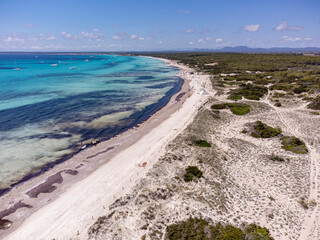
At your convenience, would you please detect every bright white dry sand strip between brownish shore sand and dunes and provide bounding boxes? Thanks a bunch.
[4,62,208,240]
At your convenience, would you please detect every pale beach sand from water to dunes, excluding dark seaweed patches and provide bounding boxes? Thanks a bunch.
[0,58,209,240]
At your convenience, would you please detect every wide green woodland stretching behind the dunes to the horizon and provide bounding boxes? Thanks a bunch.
[147,52,320,97]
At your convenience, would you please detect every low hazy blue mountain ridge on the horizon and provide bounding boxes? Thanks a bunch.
[193,46,320,53]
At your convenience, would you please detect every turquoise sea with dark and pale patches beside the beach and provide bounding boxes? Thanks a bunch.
[0,54,182,194]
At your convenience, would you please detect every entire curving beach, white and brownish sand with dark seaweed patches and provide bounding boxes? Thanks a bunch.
[0,59,211,239]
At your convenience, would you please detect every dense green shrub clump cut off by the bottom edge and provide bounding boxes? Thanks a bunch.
[165,218,273,240]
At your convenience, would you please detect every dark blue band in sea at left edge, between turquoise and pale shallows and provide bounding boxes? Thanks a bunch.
[0,91,125,131]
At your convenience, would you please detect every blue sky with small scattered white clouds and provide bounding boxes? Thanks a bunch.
[0,0,320,51]
